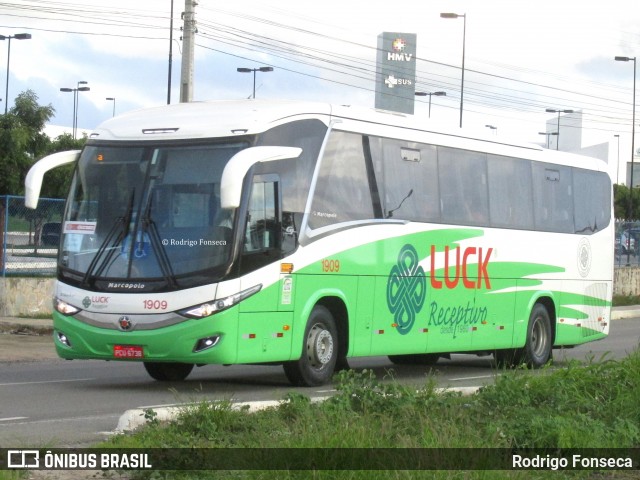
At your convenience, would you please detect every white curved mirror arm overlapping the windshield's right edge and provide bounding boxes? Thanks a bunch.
[220,147,302,209]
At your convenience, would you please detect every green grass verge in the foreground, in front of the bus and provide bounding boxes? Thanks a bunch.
[103,352,640,480]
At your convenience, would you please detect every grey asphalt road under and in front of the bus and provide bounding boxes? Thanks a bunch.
[0,318,640,448]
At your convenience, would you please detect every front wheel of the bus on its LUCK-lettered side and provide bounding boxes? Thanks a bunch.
[284,305,338,387]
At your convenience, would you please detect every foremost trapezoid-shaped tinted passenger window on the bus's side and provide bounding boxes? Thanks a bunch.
[309,131,374,228]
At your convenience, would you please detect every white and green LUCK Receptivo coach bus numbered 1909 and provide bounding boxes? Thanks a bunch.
[26,100,614,386]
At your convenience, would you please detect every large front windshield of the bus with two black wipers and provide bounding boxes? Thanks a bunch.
[59,142,248,291]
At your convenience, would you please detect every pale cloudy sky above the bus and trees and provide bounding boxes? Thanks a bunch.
[0,0,640,182]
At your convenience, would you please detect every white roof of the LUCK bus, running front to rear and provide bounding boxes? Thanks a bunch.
[89,99,606,171]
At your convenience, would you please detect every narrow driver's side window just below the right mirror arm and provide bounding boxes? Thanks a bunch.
[241,175,282,272]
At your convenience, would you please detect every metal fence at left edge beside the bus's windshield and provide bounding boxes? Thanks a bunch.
[0,195,64,277]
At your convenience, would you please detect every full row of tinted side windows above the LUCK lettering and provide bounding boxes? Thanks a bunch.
[302,132,611,235]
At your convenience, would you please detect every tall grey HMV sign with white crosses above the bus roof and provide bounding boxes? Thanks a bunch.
[375,32,417,114]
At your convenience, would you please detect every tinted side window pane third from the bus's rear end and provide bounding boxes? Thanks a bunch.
[487,155,533,230]
